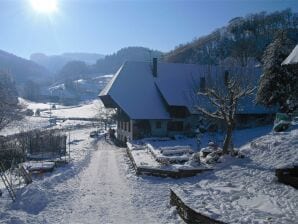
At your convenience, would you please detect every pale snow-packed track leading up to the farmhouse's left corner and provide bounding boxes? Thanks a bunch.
[64,142,159,223]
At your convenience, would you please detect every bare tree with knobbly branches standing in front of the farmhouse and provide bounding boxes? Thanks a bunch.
[196,69,256,154]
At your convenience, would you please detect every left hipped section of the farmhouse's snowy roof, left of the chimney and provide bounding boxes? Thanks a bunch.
[99,62,170,119]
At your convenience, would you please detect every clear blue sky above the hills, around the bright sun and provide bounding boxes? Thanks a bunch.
[0,0,298,58]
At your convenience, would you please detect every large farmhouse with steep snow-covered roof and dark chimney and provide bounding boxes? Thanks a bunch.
[99,59,268,142]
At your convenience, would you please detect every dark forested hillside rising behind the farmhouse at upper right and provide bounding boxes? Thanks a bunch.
[165,9,298,65]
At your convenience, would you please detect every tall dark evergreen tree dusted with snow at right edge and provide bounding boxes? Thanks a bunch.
[257,33,297,112]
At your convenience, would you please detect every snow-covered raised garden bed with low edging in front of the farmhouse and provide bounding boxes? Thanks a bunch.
[127,139,210,178]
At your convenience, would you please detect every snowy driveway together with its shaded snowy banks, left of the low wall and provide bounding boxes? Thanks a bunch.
[0,129,183,224]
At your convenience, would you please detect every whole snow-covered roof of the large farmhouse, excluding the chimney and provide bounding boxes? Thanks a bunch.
[99,61,268,119]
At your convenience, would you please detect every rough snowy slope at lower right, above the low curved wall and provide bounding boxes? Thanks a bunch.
[174,129,298,224]
